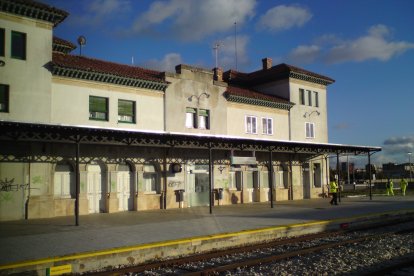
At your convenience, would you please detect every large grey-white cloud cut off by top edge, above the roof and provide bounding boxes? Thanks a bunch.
[128,0,256,41]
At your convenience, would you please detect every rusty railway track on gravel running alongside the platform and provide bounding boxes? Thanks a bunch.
[90,220,414,275]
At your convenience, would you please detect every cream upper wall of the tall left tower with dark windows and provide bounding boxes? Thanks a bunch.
[0,12,52,123]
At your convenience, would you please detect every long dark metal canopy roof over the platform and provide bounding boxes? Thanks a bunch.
[0,121,381,155]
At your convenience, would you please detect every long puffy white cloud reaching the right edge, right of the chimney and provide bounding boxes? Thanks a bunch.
[289,25,414,64]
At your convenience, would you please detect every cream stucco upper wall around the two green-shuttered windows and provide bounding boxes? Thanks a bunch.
[51,77,164,131]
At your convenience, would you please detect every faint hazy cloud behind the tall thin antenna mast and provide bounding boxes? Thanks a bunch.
[212,35,250,70]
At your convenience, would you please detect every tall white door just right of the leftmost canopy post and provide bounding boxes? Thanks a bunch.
[87,165,102,214]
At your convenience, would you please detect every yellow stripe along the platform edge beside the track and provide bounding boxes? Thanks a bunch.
[0,209,414,270]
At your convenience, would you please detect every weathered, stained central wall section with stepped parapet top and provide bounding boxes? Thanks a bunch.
[165,65,227,135]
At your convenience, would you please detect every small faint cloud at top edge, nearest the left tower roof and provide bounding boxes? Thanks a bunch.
[69,0,131,27]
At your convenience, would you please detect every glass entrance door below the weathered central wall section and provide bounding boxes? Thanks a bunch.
[185,165,209,207]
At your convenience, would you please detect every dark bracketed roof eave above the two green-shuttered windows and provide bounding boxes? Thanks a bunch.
[52,64,169,92]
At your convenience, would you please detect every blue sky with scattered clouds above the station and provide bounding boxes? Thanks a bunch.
[41,0,414,165]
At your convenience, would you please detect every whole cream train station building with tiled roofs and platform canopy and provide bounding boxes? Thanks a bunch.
[0,0,381,220]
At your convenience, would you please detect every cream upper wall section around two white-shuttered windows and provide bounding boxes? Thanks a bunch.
[227,103,289,140]
